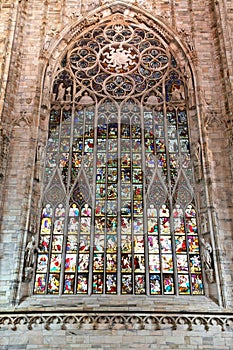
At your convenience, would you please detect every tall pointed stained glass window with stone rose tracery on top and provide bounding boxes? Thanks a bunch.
[34,18,204,296]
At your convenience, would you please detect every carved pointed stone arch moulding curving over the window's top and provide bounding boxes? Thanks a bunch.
[18,1,224,304]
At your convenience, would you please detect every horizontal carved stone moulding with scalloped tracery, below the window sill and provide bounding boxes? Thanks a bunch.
[0,310,233,331]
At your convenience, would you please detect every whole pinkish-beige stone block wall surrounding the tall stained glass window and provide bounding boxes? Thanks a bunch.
[0,0,233,350]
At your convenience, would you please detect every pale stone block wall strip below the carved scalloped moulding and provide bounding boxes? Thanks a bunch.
[0,325,232,350]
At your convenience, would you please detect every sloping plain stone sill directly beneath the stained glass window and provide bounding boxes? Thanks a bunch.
[10,295,228,313]
